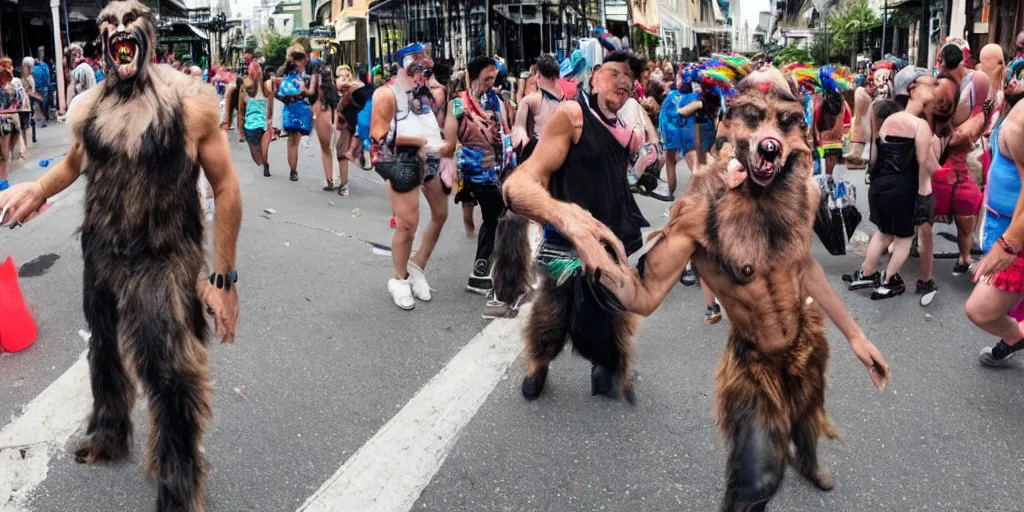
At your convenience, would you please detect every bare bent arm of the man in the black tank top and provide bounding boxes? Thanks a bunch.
[502,102,628,283]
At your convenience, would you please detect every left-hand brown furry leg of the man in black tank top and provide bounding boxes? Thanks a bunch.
[522,278,570,400]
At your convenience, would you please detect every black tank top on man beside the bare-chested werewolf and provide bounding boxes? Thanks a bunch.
[548,94,650,254]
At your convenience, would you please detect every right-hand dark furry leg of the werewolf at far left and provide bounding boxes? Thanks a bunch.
[121,270,213,512]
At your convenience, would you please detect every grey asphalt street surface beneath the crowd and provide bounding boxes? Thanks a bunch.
[0,120,1024,512]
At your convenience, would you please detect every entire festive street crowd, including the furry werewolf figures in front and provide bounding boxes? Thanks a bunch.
[6,0,1024,510]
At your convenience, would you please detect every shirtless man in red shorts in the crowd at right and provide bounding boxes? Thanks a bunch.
[922,42,992,279]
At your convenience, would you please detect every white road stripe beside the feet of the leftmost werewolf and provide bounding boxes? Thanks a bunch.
[0,350,92,512]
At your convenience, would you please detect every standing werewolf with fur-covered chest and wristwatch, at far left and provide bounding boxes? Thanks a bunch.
[0,0,242,512]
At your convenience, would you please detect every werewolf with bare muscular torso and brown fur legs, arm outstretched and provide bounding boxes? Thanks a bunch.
[592,70,889,512]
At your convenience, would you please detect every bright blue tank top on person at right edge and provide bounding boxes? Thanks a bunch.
[981,123,1021,253]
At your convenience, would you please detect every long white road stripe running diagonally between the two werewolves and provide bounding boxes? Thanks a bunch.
[298,304,530,512]
